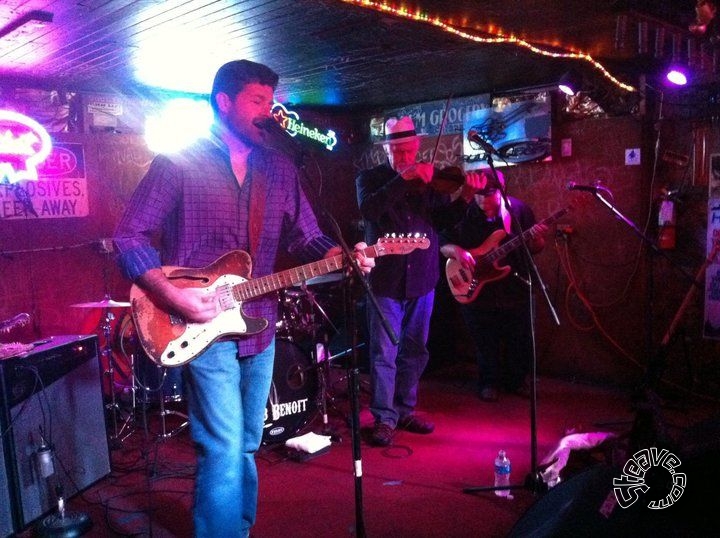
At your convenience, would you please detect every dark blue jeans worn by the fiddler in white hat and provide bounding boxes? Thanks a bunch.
[368,290,435,428]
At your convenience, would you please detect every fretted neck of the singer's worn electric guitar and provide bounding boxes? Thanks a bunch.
[233,245,380,301]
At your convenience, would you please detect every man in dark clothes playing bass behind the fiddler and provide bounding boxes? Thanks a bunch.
[440,172,547,401]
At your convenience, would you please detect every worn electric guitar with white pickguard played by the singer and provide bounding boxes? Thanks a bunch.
[130,235,430,366]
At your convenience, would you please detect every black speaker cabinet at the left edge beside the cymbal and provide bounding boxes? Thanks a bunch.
[0,336,110,536]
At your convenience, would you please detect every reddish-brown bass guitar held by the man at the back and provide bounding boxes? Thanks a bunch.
[445,208,570,304]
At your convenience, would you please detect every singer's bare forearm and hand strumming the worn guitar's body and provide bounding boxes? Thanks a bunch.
[139,269,220,323]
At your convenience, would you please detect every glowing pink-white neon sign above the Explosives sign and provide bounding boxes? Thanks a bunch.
[0,110,52,184]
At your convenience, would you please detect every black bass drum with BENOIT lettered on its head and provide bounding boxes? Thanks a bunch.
[263,339,318,445]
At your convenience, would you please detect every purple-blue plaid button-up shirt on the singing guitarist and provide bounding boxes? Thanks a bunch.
[114,135,334,356]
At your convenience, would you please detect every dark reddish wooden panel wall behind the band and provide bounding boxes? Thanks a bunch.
[0,114,720,392]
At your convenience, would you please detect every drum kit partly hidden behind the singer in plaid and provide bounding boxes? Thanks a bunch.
[70,273,358,445]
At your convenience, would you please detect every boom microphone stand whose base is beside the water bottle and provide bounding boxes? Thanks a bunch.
[463,144,560,494]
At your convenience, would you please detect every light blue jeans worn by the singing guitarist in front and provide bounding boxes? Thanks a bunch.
[185,341,275,538]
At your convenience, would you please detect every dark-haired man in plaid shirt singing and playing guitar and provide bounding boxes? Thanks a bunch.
[114,60,374,538]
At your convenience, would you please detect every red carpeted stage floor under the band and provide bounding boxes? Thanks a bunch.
[15,358,718,538]
